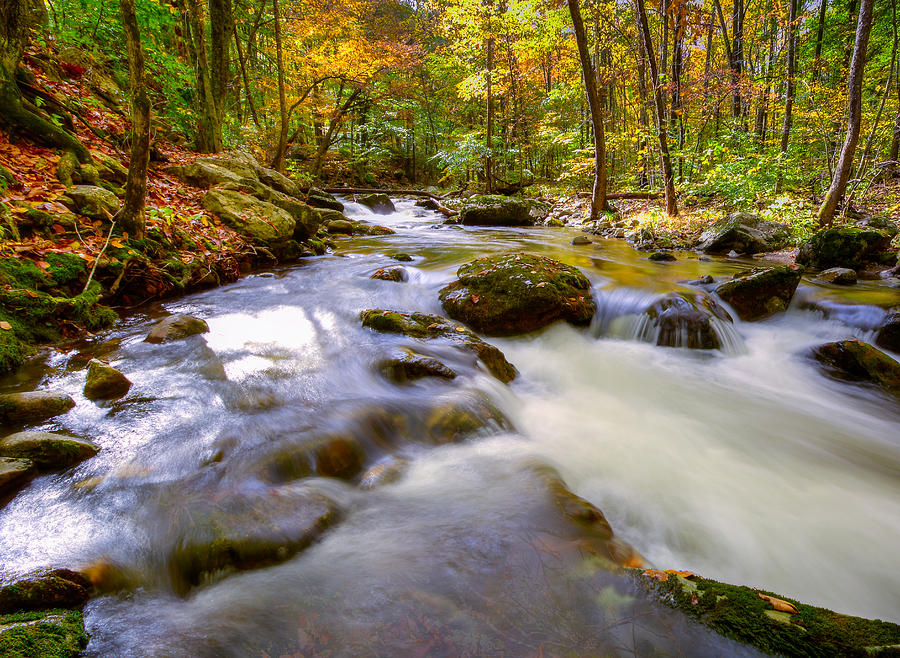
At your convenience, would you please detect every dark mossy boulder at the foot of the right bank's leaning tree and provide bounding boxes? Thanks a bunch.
[797,228,893,270]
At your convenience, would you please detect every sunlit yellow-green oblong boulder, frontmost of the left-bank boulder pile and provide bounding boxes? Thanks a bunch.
[203,189,297,241]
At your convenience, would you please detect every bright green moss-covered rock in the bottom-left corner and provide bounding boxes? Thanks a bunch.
[0,610,90,658]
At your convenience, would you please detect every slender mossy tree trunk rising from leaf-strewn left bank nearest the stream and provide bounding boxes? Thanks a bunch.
[117,0,150,240]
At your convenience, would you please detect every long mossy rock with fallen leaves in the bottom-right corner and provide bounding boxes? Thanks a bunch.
[634,571,900,658]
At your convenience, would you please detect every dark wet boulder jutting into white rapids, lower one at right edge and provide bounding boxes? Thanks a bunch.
[812,339,900,395]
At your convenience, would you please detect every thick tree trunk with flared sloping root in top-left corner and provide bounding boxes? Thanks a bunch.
[0,0,91,162]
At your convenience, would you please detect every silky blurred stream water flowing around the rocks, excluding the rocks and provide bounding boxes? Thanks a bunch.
[0,201,900,656]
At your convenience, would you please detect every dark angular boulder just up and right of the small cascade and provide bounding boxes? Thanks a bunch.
[715,265,802,322]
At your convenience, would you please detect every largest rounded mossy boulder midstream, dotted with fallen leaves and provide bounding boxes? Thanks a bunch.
[440,253,596,336]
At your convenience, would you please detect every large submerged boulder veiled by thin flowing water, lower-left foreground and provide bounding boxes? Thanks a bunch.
[168,485,340,594]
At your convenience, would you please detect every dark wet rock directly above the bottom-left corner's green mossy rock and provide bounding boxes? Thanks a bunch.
[0,569,91,614]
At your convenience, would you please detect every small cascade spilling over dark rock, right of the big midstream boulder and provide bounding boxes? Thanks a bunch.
[591,288,745,354]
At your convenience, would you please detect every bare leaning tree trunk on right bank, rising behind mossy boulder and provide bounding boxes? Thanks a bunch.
[818,0,874,226]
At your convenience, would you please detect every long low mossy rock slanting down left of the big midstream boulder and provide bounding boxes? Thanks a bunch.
[361,309,517,383]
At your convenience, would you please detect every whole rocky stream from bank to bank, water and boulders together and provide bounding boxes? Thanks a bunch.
[0,197,900,656]
